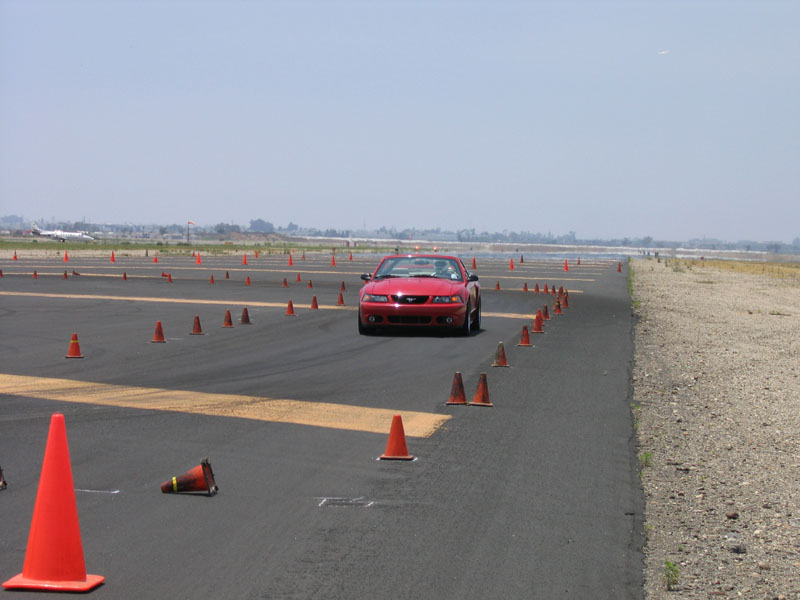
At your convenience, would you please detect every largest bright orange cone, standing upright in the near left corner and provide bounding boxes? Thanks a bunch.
[3,413,105,592]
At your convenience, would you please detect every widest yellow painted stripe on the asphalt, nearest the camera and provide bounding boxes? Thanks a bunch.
[0,374,450,437]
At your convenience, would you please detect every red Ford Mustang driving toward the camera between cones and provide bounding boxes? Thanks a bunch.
[358,254,481,335]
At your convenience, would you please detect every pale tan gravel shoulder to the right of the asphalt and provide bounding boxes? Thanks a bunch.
[631,259,800,599]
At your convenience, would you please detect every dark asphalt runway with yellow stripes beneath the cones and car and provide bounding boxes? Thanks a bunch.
[0,250,644,600]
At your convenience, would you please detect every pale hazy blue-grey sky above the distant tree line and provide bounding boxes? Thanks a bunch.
[0,0,800,241]
